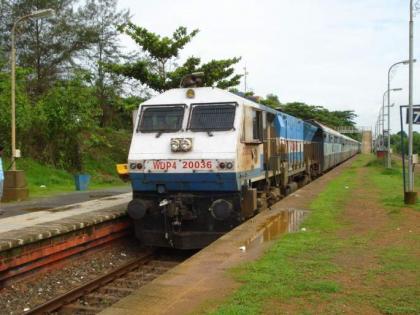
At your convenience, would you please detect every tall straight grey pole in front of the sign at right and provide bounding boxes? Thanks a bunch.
[404,0,417,204]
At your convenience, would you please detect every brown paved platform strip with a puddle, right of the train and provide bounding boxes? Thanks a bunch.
[100,159,353,315]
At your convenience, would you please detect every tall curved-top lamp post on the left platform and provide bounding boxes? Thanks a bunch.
[10,9,54,171]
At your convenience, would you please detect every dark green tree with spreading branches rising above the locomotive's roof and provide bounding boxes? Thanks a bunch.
[107,23,241,92]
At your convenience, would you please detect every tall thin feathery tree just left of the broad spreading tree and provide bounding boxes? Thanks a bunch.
[80,0,129,126]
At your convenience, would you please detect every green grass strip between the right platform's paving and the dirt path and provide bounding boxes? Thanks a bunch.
[210,156,367,314]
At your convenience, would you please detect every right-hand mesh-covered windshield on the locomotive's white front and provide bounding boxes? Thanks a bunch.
[188,103,236,131]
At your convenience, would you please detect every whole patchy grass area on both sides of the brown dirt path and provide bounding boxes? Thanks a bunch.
[207,156,420,315]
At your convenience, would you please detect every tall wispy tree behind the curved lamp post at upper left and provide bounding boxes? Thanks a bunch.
[2,0,94,99]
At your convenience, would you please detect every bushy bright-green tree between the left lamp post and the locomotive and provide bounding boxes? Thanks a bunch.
[31,72,99,171]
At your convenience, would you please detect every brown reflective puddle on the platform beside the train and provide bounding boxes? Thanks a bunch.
[240,209,308,250]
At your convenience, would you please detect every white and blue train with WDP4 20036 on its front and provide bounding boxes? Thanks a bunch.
[119,87,360,249]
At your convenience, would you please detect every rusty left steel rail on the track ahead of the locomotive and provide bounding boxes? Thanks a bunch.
[24,250,154,315]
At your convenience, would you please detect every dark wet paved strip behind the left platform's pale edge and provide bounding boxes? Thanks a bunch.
[0,186,131,218]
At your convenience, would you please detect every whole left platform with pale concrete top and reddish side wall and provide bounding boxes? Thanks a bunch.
[0,193,132,285]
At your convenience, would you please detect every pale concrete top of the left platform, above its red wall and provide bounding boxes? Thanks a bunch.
[0,193,132,251]
